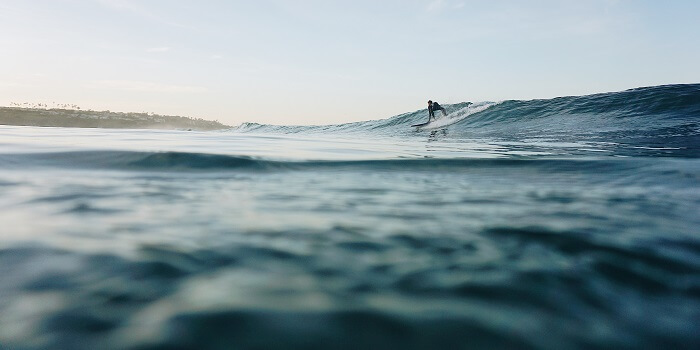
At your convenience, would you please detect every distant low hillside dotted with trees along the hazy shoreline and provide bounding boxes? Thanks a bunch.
[0,107,230,130]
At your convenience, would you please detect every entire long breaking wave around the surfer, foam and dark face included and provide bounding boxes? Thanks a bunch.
[232,84,700,157]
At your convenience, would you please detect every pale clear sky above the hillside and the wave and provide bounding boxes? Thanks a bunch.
[0,0,700,125]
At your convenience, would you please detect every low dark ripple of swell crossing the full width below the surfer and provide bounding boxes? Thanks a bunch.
[0,151,697,173]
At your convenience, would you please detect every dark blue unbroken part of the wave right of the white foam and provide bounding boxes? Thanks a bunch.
[458,84,700,134]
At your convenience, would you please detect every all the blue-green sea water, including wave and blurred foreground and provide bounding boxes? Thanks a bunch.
[0,84,700,349]
